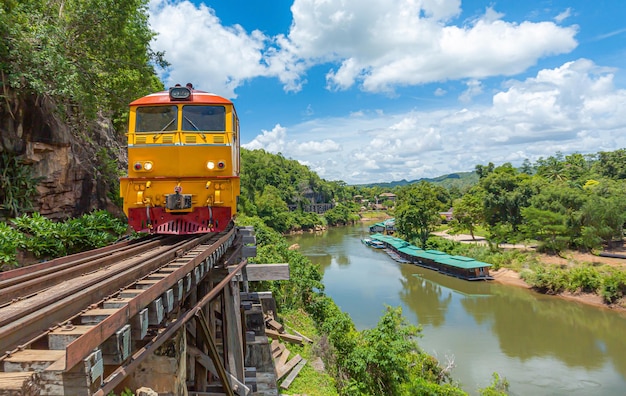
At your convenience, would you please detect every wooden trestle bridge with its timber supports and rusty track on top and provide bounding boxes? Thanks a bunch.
[0,227,289,396]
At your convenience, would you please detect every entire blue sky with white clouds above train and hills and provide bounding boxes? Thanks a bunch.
[149,0,626,185]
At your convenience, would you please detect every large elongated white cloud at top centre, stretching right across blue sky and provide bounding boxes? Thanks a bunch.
[278,0,577,92]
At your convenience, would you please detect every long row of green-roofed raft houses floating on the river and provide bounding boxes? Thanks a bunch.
[370,233,493,280]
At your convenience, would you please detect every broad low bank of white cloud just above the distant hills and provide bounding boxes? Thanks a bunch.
[246,59,626,184]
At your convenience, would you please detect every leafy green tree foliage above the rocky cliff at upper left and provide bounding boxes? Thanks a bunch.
[0,0,167,127]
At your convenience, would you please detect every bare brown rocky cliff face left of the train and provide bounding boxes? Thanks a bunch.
[0,90,127,219]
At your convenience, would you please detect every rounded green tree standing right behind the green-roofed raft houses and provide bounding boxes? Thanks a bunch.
[395,181,444,247]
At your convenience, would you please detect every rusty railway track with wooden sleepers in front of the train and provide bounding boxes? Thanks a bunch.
[0,224,240,395]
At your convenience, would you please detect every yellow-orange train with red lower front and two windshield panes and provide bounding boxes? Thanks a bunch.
[120,83,241,235]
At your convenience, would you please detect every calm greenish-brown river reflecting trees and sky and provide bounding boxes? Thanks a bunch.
[289,225,626,396]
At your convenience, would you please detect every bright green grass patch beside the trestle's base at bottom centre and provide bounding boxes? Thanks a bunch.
[278,310,338,396]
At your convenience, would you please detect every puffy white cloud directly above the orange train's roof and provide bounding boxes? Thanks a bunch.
[149,0,269,98]
